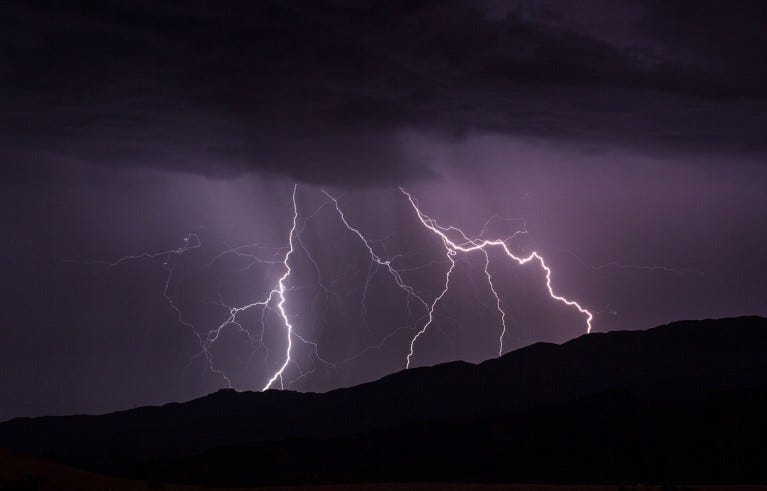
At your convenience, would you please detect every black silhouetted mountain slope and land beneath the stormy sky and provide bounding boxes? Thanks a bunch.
[0,317,767,489]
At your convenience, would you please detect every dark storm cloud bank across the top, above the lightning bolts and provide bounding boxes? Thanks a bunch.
[0,1,767,185]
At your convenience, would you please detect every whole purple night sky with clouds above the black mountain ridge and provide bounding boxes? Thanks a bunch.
[0,0,767,420]
